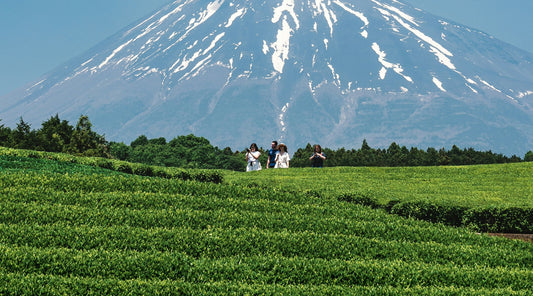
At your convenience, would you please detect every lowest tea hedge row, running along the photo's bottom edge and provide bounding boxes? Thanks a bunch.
[0,273,531,296]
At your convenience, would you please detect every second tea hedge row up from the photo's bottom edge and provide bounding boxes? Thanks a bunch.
[0,245,533,291]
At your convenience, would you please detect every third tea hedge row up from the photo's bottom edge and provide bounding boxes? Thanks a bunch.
[0,222,533,269]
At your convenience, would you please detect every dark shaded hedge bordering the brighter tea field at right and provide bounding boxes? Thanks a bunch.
[337,193,533,234]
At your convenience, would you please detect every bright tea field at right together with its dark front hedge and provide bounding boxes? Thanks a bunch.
[225,163,533,233]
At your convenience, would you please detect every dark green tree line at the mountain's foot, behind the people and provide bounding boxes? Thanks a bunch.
[0,114,533,171]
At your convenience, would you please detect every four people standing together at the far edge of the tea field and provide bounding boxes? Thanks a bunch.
[246,141,326,172]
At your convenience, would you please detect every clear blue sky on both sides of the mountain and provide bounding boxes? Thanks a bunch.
[0,0,533,95]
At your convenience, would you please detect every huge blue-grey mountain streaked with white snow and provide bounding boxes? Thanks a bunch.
[0,0,533,155]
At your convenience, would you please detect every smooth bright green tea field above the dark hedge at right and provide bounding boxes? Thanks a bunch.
[225,162,533,207]
